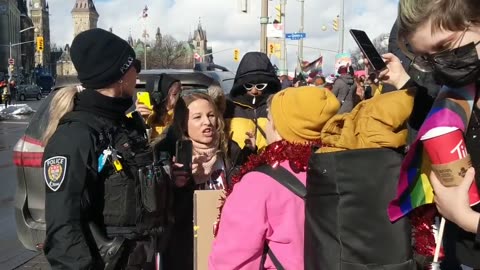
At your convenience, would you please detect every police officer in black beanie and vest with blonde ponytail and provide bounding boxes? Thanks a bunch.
[43,29,168,269]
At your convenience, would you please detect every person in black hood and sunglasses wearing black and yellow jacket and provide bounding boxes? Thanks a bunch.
[225,52,282,150]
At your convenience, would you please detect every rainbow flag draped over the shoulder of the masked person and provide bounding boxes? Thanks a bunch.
[388,84,479,222]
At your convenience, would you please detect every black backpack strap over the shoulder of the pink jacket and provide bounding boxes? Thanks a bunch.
[254,165,307,200]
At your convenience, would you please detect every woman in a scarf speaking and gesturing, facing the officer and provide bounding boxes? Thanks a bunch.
[155,93,252,269]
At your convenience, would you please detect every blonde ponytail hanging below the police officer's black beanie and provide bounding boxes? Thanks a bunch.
[42,86,82,145]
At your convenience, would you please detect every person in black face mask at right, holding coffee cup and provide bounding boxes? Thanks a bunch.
[380,0,480,269]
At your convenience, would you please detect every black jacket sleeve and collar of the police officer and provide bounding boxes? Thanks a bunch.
[43,90,138,269]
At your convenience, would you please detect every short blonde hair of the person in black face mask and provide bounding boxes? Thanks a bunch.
[398,0,480,40]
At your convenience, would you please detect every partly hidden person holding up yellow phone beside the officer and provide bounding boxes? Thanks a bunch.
[135,74,182,140]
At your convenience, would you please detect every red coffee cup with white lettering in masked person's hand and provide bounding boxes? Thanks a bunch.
[422,129,480,205]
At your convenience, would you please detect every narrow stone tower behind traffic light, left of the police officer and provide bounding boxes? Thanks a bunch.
[30,0,52,71]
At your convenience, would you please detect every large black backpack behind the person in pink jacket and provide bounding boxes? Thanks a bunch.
[305,148,416,270]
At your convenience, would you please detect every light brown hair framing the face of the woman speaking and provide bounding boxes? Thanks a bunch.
[172,93,228,154]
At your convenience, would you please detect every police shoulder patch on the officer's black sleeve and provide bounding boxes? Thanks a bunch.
[43,156,67,191]
